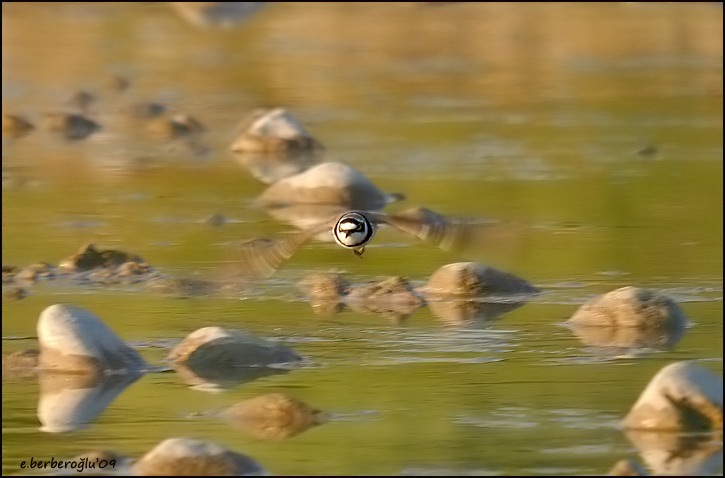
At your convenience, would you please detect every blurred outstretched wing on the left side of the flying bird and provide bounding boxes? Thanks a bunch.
[241,217,332,278]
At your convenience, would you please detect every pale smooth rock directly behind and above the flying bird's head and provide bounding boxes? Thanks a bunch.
[258,162,403,210]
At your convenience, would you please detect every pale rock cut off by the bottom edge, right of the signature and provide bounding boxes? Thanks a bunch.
[133,438,267,476]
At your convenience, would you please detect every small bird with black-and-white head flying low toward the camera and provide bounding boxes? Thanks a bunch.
[242,208,472,277]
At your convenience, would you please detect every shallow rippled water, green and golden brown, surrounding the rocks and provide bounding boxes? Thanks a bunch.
[2,3,723,475]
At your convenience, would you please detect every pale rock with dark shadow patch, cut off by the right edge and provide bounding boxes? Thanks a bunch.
[622,361,723,432]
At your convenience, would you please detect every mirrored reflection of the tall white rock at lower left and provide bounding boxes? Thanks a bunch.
[38,371,143,433]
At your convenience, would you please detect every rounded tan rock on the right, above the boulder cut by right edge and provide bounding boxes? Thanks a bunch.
[569,286,688,329]
